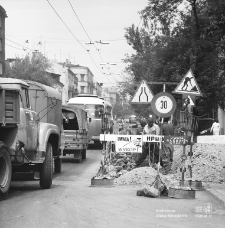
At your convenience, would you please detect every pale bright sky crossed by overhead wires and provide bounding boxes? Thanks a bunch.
[0,0,148,86]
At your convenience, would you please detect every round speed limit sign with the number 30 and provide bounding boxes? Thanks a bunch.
[151,92,177,117]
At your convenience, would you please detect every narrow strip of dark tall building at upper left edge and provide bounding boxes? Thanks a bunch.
[0,6,7,77]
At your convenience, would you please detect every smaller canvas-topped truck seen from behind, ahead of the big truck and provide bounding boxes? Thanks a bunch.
[60,105,90,162]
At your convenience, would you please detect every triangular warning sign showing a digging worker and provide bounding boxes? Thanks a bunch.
[173,70,202,96]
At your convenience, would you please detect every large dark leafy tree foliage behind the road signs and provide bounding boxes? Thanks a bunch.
[121,0,225,115]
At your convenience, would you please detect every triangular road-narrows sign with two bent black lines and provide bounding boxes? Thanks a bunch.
[131,80,153,104]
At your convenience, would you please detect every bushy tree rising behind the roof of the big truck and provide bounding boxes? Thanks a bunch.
[5,53,55,86]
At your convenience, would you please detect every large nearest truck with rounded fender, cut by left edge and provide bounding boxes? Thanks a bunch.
[0,78,62,198]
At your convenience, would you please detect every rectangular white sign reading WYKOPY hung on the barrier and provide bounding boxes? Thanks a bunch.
[116,135,142,153]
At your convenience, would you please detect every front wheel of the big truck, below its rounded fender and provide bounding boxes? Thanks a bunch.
[40,143,53,189]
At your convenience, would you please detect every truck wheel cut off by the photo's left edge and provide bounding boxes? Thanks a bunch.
[0,142,12,200]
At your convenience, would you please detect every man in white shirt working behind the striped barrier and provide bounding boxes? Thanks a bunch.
[136,118,160,167]
